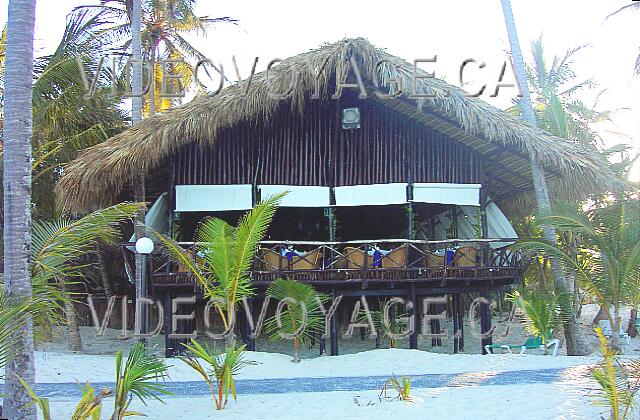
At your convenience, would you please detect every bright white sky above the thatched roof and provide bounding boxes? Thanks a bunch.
[0,0,640,180]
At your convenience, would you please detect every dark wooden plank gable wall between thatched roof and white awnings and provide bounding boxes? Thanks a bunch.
[175,99,482,186]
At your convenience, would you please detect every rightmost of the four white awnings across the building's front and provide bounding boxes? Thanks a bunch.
[413,183,482,206]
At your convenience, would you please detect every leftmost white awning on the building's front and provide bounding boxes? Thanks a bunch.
[176,184,253,212]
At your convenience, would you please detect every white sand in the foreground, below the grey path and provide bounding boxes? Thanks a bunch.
[46,385,602,420]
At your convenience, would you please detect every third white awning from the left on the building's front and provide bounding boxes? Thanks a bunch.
[335,183,408,206]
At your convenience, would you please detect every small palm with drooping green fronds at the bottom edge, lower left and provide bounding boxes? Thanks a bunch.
[111,342,171,420]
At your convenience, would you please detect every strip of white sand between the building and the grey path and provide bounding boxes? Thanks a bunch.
[21,349,597,382]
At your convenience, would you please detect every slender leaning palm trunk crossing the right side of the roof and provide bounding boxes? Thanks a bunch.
[500,0,588,355]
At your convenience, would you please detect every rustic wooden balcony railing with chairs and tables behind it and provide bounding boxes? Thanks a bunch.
[129,238,528,286]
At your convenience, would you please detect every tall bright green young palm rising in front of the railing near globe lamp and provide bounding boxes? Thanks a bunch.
[155,194,284,338]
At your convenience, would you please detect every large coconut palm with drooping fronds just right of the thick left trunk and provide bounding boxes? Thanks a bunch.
[0,11,127,219]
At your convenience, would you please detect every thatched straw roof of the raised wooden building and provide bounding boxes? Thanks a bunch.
[57,38,616,212]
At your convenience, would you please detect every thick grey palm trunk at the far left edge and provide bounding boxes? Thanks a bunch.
[3,0,36,420]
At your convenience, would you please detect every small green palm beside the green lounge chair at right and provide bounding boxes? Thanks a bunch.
[507,291,571,352]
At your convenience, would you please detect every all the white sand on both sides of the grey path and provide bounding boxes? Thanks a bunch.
[2,305,640,420]
